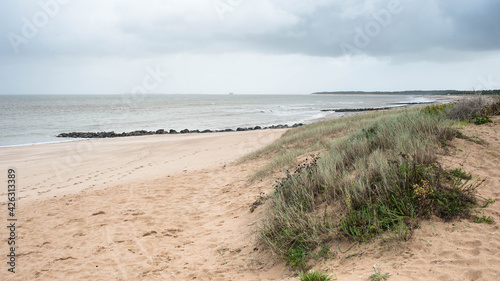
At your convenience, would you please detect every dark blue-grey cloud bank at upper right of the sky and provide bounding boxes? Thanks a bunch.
[229,0,500,58]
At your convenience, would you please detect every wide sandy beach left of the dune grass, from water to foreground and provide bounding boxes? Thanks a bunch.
[0,130,292,280]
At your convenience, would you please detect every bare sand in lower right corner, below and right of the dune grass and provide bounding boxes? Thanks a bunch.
[310,117,500,281]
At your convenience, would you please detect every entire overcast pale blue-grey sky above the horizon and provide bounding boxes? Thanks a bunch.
[0,0,500,94]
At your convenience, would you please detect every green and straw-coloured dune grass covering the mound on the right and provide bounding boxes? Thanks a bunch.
[247,95,500,272]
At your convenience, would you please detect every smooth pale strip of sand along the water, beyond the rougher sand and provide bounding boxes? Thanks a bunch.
[0,130,286,204]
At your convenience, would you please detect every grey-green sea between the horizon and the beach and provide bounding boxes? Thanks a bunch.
[0,94,442,146]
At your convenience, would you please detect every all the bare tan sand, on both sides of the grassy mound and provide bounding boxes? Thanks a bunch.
[0,117,500,280]
